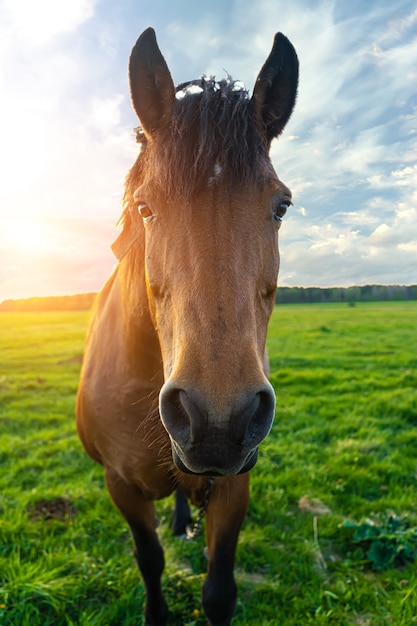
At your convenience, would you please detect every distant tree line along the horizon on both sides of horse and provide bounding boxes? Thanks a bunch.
[0,285,417,311]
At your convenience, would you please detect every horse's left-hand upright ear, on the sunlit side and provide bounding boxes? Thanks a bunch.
[129,28,175,137]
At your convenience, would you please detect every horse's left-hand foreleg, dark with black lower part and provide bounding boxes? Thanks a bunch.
[105,471,168,626]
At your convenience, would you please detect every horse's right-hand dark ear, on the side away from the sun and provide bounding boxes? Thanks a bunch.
[252,33,298,145]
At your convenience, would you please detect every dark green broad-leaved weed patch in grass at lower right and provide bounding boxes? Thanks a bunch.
[340,512,417,571]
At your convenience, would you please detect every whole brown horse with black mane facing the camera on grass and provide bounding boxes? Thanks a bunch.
[77,28,298,626]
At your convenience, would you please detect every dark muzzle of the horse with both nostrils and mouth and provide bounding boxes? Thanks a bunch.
[159,381,275,476]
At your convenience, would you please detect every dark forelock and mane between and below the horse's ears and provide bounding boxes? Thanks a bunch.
[122,76,269,223]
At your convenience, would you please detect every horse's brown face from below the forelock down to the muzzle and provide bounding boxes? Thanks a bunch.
[140,179,289,474]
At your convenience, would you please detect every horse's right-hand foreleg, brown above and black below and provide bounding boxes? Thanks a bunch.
[203,474,249,626]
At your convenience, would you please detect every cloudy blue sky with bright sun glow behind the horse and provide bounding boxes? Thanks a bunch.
[0,0,417,301]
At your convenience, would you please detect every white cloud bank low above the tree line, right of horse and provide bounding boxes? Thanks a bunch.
[279,194,417,286]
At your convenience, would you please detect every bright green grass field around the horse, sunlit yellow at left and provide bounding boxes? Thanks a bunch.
[0,303,417,626]
